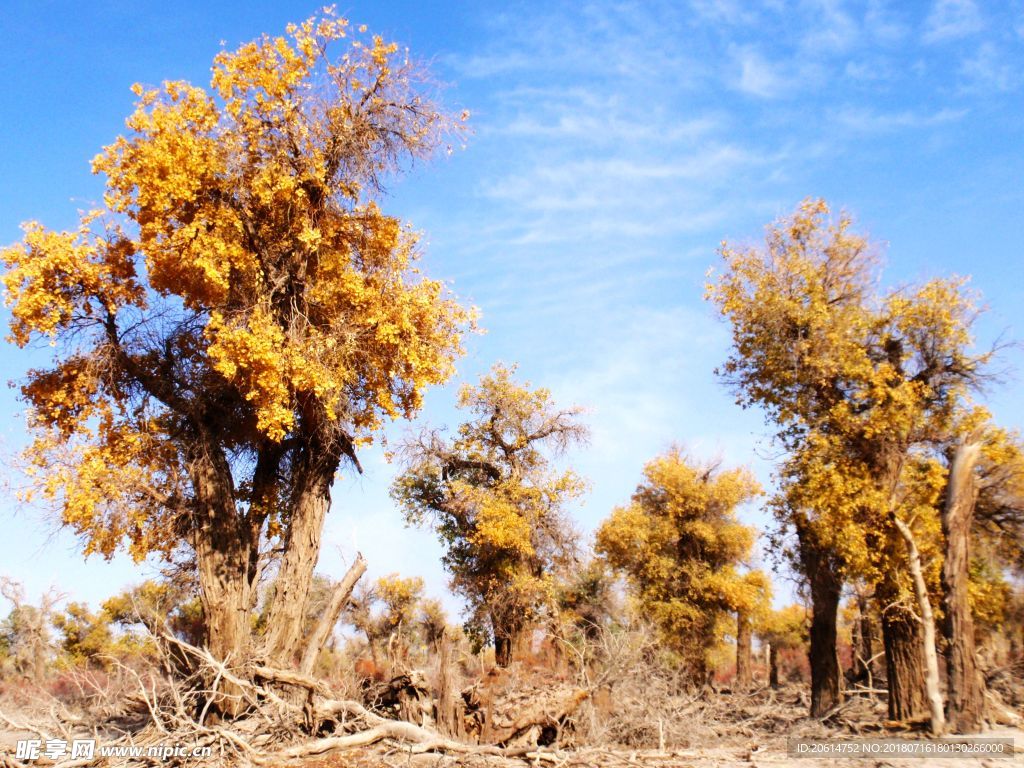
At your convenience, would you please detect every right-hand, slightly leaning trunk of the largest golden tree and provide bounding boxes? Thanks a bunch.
[264,445,340,668]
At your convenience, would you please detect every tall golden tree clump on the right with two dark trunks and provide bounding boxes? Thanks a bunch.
[710,200,989,719]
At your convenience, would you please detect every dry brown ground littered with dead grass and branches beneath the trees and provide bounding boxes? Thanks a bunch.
[0,633,1024,768]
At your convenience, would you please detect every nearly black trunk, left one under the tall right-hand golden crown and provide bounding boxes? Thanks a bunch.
[797,523,843,718]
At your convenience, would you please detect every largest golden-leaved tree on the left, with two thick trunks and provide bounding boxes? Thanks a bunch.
[2,13,472,704]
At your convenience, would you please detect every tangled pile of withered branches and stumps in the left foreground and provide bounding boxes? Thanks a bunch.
[0,634,588,768]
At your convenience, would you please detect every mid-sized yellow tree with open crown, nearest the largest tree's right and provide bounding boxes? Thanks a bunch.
[392,365,587,667]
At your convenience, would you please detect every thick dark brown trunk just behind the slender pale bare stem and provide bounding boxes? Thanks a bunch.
[882,603,926,720]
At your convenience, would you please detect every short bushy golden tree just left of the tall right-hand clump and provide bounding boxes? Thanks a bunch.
[596,447,769,684]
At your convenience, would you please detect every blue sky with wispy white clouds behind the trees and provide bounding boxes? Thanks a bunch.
[0,0,1024,618]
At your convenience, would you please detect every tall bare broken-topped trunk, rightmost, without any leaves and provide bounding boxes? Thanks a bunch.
[942,441,985,733]
